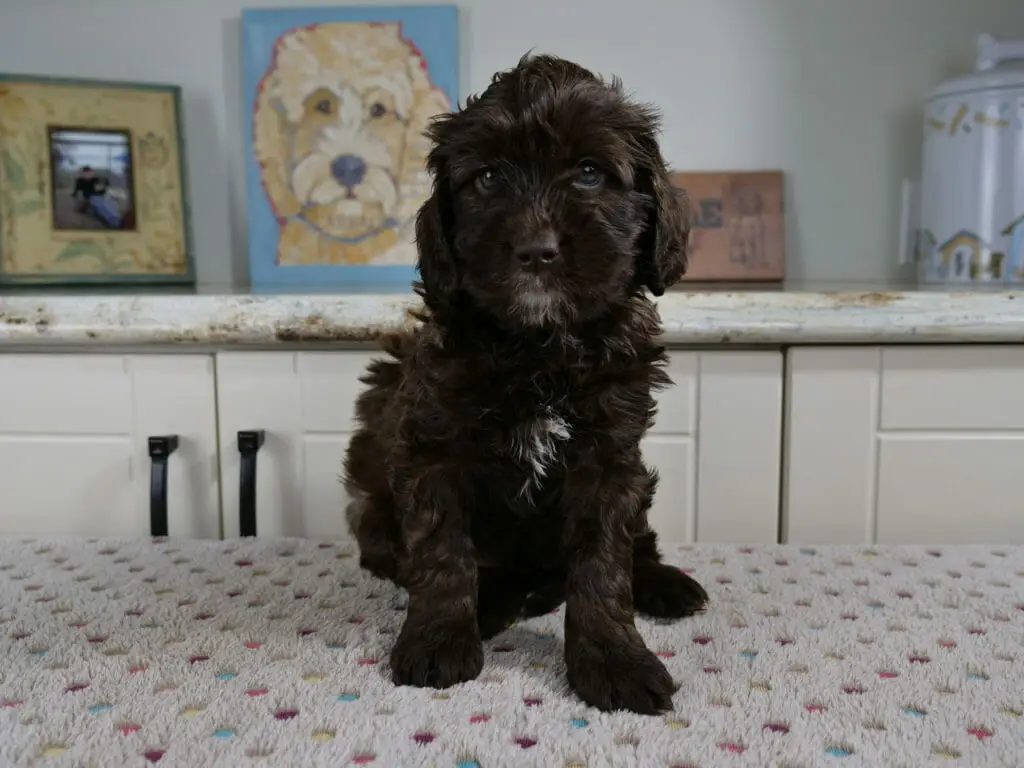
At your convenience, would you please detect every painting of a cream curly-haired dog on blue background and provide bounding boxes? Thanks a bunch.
[242,5,459,290]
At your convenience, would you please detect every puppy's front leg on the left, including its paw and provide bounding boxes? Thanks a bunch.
[391,468,483,688]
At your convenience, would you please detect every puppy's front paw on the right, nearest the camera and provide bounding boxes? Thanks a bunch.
[565,643,678,715]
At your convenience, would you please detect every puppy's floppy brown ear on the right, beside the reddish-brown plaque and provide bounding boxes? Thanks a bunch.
[637,135,691,296]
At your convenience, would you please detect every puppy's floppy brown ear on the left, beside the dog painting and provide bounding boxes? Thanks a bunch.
[416,165,459,310]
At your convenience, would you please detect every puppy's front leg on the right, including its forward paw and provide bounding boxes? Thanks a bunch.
[563,461,677,715]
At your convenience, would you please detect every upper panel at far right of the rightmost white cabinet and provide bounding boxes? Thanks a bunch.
[880,346,1024,430]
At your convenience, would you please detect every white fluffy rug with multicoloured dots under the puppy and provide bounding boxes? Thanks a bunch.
[0,539,1024,768]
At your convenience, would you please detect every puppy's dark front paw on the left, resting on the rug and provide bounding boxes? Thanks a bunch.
[391,620,483,688]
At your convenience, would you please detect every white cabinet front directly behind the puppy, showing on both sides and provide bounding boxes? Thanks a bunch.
[217,350,782,543]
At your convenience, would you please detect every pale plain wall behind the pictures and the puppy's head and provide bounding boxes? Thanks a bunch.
[0,0,1024,284]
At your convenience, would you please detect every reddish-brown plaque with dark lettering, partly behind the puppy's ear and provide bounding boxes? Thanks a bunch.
[673,171,785,283]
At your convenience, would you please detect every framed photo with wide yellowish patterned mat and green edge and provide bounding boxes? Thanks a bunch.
[0,75,195,285]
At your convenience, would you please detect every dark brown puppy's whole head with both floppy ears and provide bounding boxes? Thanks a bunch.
[417,56,690,327]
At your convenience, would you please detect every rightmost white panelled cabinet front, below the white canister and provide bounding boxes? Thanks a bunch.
[783,346,1024,544]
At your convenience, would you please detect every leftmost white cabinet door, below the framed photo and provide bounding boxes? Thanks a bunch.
[0,353,220,538]
